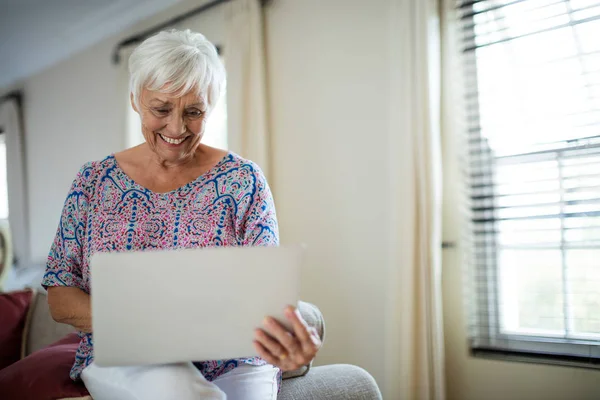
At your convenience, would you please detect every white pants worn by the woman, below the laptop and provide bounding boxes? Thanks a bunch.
[81,363,279,400]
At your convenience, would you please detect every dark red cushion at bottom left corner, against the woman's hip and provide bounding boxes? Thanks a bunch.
[0,333,89,400]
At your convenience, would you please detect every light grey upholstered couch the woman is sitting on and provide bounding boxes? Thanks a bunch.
[17,289,381,400]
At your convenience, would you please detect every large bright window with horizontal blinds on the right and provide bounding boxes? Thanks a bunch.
[458,0,600,364]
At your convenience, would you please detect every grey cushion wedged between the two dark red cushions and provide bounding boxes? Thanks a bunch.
[21,289,75,358]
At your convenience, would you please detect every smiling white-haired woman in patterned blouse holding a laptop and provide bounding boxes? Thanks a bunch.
[42,30,320,400]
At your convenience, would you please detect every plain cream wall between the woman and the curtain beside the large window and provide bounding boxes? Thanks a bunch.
[267,0,390,387]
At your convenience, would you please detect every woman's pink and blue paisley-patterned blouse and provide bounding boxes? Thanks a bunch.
[42,153,279,381]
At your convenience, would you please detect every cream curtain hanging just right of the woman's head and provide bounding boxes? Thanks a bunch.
[224,0,270,178]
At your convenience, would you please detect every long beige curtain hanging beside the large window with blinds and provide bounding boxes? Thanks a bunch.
[384,0,445,400]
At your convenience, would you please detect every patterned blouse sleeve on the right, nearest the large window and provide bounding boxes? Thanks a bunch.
[242,166,279,246]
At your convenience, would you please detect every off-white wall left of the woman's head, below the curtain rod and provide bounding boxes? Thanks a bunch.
[24,42,125,262]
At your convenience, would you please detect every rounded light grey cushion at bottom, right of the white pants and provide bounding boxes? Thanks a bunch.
[277,364,382,400]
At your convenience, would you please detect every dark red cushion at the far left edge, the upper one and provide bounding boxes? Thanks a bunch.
[0,289,34,370]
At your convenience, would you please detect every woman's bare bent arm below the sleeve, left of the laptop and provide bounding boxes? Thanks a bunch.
[48,286,92,333]
